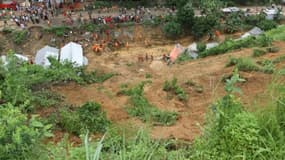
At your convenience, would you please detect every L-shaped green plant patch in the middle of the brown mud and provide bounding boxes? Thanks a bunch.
[121,82,177,125]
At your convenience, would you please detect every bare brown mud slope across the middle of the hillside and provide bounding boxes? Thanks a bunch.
[53,42,285,140]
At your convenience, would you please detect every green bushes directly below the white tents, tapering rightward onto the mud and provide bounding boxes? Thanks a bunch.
[0,54,113,109]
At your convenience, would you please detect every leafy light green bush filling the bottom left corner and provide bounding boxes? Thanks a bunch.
[0,104,52,160]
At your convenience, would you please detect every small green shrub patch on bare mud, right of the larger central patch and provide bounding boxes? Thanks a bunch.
[163,78,188,101]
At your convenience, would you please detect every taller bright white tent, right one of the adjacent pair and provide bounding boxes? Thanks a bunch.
[60,42,84,66]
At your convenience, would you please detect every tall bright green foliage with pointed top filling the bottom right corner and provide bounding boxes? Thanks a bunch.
[191,69,285,160]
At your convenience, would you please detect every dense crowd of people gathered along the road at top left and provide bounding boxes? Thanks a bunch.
[0,3,172,28]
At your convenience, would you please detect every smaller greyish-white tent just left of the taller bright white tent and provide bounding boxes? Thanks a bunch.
[35,46,59,67]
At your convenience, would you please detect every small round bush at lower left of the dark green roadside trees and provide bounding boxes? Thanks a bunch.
[163,22,182,38]
